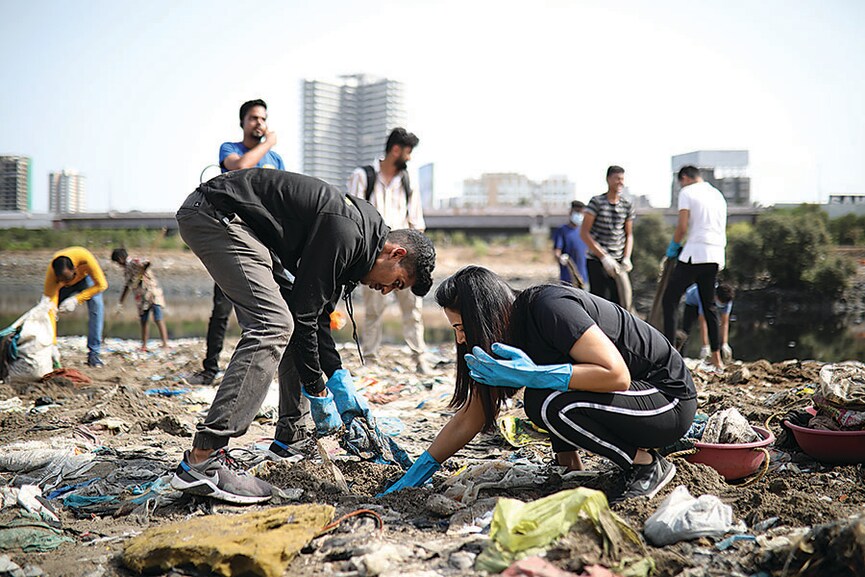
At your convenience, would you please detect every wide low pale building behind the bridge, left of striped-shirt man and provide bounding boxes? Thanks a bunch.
[460,172,577,207]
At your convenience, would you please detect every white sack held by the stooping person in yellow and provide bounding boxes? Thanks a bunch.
[9,299,54,380]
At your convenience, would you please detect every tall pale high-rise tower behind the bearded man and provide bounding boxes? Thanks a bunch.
[301,74,405,188]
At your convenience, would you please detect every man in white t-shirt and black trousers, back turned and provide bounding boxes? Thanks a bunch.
[663,166,727,368]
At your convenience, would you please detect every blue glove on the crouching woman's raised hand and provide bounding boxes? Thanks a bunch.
[466,343,574,391]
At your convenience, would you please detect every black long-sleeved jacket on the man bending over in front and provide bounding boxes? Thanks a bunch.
[201,168,389,385]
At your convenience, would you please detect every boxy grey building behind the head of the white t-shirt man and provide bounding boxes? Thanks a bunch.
[670,150,751,208]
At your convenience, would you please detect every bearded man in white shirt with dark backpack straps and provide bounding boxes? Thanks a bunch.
[348,128,431,374]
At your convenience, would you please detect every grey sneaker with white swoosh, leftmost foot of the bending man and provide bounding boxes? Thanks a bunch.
[171,449,273,505]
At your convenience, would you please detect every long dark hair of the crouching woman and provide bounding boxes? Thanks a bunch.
[436,265,519,431]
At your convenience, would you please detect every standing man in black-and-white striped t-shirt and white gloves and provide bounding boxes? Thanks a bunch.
[581,165,636,306]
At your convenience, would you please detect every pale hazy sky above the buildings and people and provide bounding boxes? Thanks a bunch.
[0,0,865,212]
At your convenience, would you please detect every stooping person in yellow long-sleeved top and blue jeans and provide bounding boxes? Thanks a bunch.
[44,246,108,367]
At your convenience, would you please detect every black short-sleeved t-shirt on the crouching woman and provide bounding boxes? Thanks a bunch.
[512,285,697,400]
